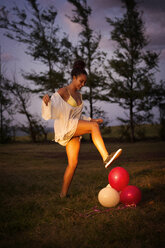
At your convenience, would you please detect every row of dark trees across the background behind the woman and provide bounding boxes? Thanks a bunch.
[0,0,165,143]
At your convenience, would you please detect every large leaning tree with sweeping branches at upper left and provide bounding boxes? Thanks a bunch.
[0,0,71,93]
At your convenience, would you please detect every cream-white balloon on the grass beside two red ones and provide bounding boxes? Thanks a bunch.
[98,187,120,208]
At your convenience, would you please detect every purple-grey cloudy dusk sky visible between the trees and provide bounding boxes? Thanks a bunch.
[0,0,165,125]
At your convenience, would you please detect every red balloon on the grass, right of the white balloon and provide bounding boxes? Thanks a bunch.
[120,185,141,205]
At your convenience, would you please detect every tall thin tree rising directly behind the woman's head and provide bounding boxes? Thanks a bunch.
[68,0,106,118]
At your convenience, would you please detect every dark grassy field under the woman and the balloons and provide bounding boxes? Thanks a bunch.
[0,142,165,248]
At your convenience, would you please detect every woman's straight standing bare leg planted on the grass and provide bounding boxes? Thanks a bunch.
[60,137,80,198]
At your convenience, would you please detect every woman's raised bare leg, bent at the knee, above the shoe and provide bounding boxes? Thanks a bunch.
[74,120,108,160]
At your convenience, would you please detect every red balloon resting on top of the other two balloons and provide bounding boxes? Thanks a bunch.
[108,167,129,191]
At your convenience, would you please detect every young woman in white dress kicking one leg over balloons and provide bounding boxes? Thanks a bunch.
[42,60,122,198]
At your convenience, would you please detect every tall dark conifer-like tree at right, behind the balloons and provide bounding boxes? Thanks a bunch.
[106,0,159,142]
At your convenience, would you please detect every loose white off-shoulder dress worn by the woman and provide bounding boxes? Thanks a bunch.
[42,92,91,146]
